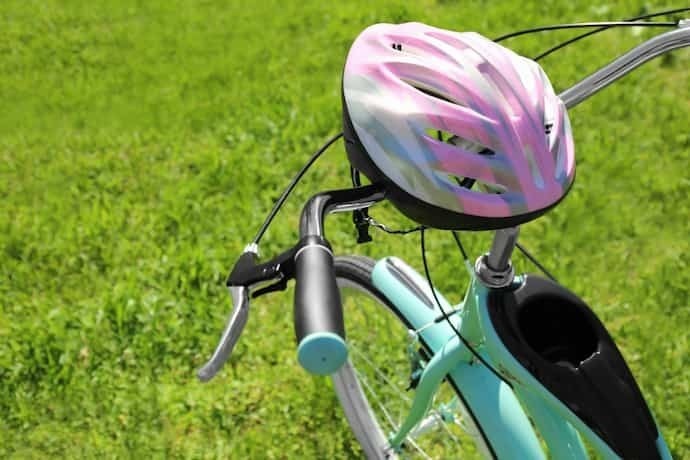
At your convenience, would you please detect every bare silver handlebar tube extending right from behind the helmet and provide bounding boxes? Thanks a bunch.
[559,19,690,109]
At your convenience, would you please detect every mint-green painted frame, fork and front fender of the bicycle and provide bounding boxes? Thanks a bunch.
[372,258,671,460]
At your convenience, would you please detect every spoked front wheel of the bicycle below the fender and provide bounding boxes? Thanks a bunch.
[332,256,487,459]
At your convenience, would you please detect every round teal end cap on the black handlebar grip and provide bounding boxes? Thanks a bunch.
[297,332,347,375]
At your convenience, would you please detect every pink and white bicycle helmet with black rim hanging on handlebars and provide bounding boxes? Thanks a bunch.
[342,23,575,230]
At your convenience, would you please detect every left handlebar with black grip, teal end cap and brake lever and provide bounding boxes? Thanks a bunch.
[197,185,385,382]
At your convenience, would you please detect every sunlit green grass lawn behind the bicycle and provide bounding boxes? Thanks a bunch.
[0,0,690,459]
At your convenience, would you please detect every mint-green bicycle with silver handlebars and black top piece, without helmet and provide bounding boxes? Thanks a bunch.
[199,9,690,459]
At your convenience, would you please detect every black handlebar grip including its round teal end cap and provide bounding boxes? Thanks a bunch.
[295,235,347,375]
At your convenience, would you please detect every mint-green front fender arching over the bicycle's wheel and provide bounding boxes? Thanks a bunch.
[372,257,545,459]
